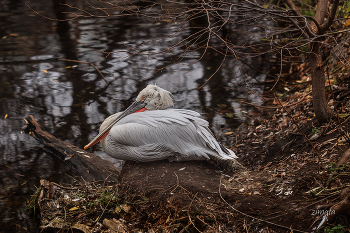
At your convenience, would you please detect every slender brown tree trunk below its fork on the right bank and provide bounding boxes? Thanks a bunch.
[310,42,328,123]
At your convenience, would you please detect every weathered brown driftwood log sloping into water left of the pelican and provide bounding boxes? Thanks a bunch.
[24,115,120,182]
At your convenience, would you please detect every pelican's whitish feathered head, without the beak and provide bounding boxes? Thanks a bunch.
[136,84,174,110]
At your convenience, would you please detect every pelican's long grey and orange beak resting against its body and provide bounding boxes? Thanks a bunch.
[84,101,147,150]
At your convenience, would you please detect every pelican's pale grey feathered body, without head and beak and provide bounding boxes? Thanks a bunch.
[101,109,237,162]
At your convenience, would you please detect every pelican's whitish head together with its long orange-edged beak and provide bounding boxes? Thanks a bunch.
[84,84,174,150]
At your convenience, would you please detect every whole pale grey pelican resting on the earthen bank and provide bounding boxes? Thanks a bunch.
[84,84,237,162]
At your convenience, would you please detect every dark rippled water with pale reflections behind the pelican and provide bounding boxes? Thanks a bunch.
[0,0,268,233]
